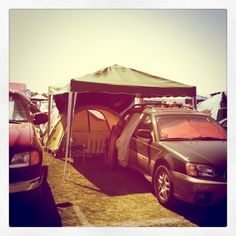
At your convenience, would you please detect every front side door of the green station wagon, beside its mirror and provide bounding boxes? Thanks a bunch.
[130,115,153,173]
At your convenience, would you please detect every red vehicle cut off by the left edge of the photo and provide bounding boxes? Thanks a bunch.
[9,91,48,203]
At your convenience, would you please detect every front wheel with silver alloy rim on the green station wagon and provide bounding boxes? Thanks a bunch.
[153,165,175,208]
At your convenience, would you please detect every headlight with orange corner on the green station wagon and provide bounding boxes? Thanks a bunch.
[186,163,216,177]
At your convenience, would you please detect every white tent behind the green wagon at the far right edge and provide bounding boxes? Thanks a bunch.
[197,91,227,121]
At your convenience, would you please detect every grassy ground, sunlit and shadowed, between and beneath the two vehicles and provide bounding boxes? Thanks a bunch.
[10,151,226,227]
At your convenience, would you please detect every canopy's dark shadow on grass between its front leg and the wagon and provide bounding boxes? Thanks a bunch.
[72,157,151,196]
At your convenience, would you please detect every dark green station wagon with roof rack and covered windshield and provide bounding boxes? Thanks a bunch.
[106,105,227,207]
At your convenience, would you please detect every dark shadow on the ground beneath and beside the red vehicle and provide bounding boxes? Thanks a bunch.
[9,166,62,227]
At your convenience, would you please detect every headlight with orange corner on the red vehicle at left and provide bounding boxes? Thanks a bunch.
[10,151,40,168]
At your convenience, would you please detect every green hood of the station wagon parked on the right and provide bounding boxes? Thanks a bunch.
[161,141,227,166]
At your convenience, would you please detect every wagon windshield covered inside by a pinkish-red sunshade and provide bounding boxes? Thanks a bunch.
[157,116,227,141]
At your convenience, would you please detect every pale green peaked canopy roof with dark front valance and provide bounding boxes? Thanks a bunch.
[49,65,196,97]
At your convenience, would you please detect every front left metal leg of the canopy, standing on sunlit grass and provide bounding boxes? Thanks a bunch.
[63,92,77,180]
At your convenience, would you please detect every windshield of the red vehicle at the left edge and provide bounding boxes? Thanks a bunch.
[9,94,28,122]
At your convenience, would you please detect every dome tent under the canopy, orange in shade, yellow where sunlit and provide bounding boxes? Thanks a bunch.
[47,105,119,154]
